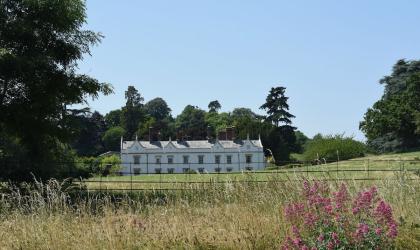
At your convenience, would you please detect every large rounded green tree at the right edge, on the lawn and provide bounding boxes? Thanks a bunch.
[360,60,420,152]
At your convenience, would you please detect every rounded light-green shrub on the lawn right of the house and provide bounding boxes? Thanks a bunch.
[303,135,366,161]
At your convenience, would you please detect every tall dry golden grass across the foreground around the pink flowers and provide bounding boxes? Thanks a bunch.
[0,176,420,249]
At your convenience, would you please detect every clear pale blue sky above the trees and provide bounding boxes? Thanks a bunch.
[80,0,420,139]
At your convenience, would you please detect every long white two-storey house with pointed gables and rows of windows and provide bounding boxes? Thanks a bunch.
[121,138,265,175]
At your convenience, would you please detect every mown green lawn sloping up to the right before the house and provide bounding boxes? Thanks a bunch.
[79,152,420,189]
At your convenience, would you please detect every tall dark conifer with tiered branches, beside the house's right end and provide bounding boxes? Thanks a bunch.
[260,87,295,127]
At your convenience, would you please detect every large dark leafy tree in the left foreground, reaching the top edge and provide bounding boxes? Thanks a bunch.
[0,0,112,180]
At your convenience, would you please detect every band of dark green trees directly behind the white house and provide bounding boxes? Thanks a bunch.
[71,86,305,163]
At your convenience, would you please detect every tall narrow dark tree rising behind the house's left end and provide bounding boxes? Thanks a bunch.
[121,86,145,140]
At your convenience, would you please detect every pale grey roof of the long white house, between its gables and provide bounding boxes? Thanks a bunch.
[122,140,262,149]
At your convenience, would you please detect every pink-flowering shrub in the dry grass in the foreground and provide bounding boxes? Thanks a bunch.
[283,181,397,249]
